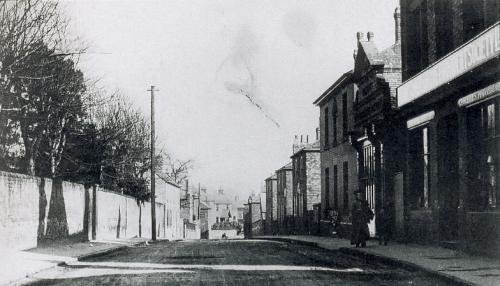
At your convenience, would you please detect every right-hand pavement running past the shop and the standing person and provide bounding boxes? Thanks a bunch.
[257,235,500,286]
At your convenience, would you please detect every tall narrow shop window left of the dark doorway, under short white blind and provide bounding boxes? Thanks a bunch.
[408,126,431,209]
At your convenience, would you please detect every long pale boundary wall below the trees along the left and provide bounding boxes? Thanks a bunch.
[0,172,176,250]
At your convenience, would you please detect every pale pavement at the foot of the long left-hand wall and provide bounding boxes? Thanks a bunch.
[0,238,147,285]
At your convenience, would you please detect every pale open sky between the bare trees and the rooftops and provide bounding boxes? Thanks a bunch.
[61,0,398,197]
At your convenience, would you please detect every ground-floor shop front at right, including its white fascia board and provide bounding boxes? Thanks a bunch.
[398,23,500,254]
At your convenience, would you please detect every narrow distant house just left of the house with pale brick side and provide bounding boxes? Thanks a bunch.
[276,162,293,233]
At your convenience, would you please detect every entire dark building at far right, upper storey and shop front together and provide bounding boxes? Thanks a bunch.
[397,0,500,253]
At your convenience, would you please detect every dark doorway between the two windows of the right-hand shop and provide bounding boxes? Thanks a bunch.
[437,114,459,241]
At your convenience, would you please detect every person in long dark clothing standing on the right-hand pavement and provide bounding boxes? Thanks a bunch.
[351,191,373,247]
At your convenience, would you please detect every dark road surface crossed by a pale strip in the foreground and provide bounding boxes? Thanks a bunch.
[26,240,458,286]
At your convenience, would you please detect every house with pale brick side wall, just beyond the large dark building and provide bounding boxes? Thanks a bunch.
[291,141,321,233]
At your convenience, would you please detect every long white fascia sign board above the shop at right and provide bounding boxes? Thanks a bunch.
[397,22,500,107]
